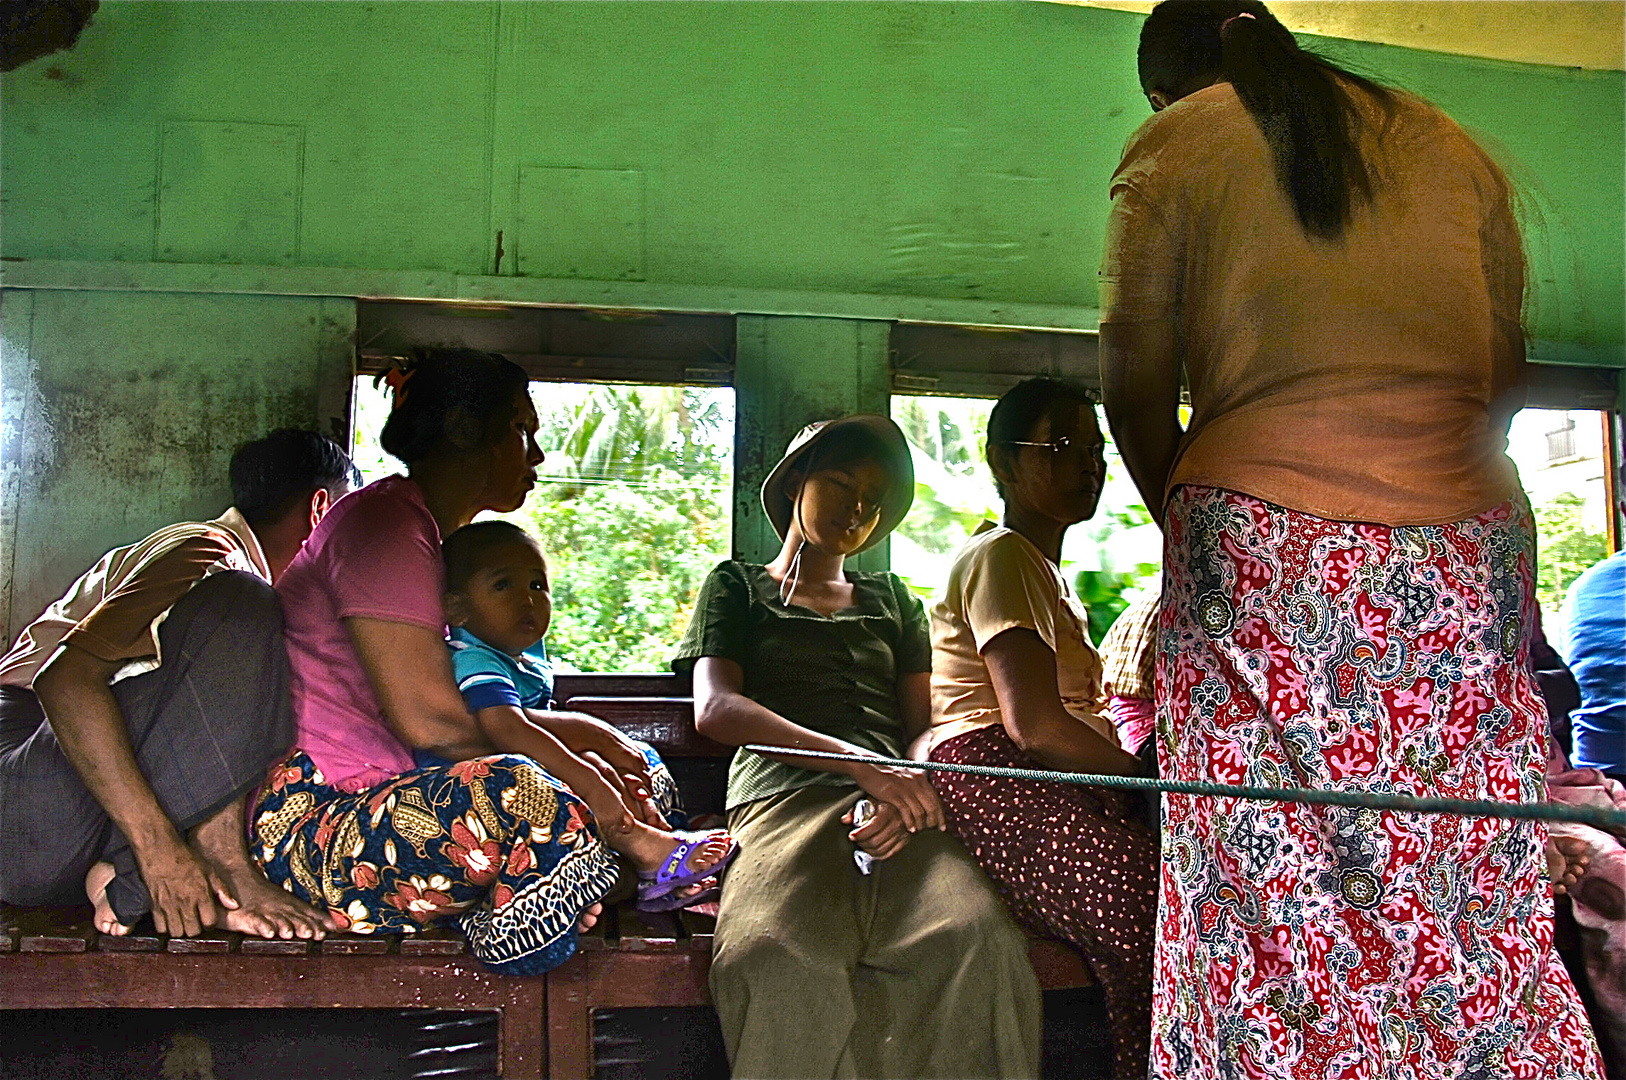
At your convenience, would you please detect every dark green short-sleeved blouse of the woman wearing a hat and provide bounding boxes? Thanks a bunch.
[672,561,932,810]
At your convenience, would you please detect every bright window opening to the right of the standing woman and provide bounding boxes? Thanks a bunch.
[1507,408,1618,639]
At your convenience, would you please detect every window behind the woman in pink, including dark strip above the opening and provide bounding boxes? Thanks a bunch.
[353,301,735,672]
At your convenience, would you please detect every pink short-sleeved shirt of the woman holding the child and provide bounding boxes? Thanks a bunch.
[276,477,446,790]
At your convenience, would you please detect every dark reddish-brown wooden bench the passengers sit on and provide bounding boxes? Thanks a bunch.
[0,675,1093,1080]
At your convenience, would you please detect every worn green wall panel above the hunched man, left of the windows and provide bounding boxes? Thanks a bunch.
[0,290,354,641]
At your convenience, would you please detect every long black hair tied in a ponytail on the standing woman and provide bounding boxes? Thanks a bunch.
[1137,0,1395,241]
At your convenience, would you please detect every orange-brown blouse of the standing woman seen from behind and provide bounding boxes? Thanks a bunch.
[1101,83,1524,525]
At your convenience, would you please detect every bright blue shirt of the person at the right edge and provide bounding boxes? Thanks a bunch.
[1561,465,1626,782]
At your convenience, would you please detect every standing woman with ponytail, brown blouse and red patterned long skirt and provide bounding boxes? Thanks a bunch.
[1101,2,1602,1080]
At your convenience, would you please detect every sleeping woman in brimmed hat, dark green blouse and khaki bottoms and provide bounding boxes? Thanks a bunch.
[673,415,1041,1077]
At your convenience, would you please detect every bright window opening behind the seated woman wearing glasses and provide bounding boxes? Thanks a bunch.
[891,394,1163,642]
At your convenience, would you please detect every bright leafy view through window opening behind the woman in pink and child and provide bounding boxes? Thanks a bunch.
[351,376,733,672]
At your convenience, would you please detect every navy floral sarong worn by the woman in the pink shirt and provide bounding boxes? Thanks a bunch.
[249,745,683,974]
